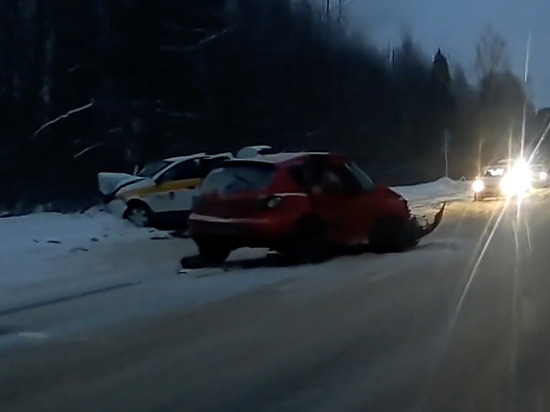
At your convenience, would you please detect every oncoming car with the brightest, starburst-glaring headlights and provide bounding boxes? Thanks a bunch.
[472,159,544,201]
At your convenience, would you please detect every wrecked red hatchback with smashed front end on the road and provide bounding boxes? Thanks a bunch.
[189,153,442,263]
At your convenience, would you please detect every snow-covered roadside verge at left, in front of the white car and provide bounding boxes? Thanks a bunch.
[0,207,179,291]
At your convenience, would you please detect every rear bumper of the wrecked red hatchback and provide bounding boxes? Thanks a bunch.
[189,213,294,248]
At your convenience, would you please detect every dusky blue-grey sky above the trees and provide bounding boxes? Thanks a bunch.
[350,0,550,108]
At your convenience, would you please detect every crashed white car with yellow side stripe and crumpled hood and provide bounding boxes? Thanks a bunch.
[97,153,233,228]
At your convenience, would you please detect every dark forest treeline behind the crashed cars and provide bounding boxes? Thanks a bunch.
[0,0,545,211]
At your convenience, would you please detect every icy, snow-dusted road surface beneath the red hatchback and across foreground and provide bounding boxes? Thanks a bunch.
[0,183,550,411]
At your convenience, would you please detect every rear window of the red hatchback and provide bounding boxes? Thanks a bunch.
[201,162,275,194]
